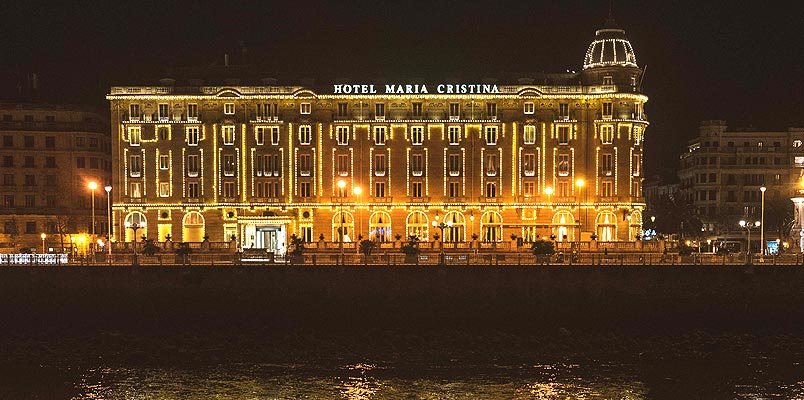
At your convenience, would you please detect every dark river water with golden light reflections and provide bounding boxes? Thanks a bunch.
[0,327,804,400]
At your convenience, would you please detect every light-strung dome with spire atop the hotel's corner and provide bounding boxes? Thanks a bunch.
[583,15,637,69]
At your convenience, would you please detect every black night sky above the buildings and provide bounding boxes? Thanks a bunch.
[0,0,804,175]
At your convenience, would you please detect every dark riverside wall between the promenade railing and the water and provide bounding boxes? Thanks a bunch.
[0,266,804,334]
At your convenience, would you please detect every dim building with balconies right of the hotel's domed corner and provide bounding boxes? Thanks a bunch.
[679,120,804,247]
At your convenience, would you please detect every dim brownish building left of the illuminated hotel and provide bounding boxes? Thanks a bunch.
[0,103,112,252]
